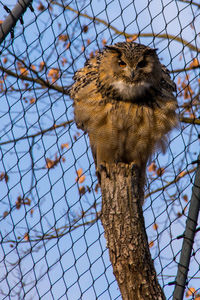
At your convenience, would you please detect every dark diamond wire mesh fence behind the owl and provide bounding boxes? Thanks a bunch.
[0,0,200,300]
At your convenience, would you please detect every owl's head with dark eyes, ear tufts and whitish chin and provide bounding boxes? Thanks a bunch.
[99,42,162,101]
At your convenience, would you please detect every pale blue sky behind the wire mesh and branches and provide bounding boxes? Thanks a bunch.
[0,0,199,300]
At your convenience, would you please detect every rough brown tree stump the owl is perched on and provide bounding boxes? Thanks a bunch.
[101,163,166,300]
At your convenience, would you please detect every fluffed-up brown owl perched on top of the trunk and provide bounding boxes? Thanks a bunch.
[70,42,177,178]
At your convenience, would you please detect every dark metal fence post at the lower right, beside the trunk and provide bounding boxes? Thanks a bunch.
[173,155,200,300]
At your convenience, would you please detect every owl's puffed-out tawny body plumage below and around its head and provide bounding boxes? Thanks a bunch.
[70,47,177,166]
